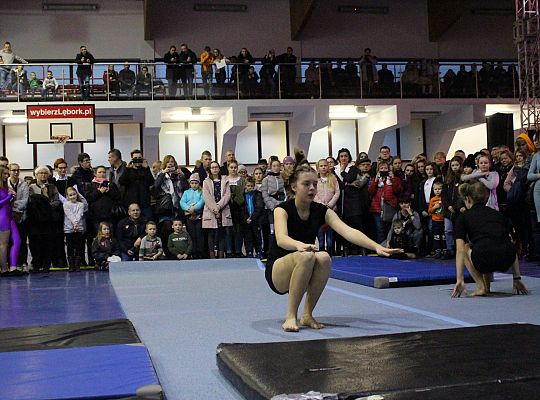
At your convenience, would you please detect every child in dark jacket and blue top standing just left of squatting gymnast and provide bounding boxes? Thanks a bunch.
[242,177,264,258]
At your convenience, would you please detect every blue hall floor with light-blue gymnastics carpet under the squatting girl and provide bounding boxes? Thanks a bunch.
[0,259,540,400]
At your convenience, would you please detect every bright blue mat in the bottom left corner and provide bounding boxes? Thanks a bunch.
[0,344,159,400]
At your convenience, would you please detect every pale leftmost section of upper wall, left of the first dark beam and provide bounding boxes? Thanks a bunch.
[0,0,153,60]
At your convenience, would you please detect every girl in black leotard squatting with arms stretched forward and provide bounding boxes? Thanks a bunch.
[265,159,402,332]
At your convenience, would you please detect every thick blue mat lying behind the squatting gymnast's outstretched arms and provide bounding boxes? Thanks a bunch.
[330,256,471,289]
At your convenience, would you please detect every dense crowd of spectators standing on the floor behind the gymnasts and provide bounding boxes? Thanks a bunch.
[0,134,540,275]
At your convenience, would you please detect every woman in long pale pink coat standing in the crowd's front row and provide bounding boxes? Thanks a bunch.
[202,161,232,258]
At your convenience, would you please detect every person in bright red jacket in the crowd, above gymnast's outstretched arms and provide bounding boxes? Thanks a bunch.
[368,161,401,243]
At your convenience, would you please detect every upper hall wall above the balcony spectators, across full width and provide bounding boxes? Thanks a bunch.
[0,0,517,59]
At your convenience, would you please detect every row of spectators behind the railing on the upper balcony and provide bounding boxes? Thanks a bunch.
[0,42,519,101]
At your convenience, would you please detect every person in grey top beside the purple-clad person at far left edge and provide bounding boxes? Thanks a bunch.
[7,163,30,272]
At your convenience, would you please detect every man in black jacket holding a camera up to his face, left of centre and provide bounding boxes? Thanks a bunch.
[118,150,154,221]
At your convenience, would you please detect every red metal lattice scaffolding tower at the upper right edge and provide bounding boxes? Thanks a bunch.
[514,0,540,132]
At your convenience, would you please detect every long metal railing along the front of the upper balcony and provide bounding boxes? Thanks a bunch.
[0,61,519,102]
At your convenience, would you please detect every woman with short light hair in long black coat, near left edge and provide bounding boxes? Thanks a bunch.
[27,166,64,272]
